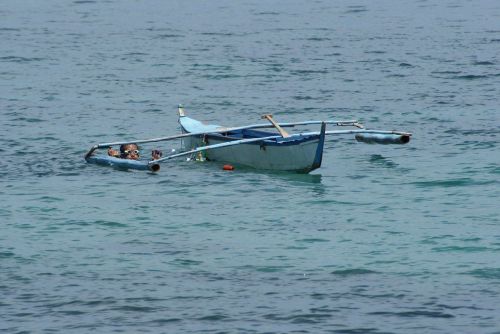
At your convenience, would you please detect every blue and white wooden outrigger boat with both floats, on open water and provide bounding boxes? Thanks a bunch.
[85,105,411,173]
